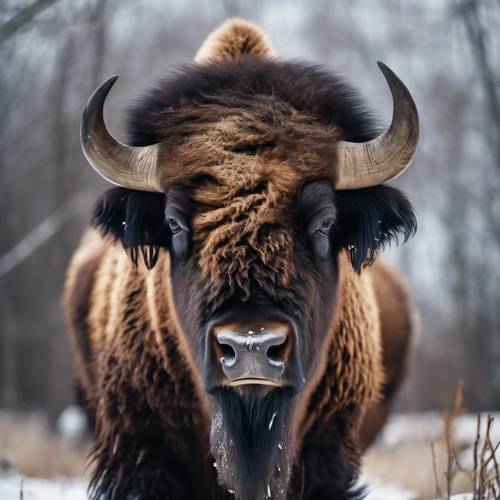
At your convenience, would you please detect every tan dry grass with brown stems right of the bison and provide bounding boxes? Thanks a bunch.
[364,384,500,500]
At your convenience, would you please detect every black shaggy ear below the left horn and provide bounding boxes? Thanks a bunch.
[91,188,169,269]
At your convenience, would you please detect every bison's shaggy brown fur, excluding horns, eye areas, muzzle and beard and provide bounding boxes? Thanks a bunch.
[65,20,413,500]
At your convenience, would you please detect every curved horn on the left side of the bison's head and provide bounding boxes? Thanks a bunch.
[80,76,163,192]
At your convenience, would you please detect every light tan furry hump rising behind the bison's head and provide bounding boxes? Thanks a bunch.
[195,18,276,64]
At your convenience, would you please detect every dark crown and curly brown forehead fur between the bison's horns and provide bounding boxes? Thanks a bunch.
[121,57,377,304]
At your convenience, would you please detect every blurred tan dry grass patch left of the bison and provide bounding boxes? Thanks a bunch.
[0,415,89,478]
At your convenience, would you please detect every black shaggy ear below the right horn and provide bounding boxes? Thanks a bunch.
[335,185,417,272]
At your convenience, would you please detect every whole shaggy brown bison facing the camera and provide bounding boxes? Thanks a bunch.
[65,20,419,500]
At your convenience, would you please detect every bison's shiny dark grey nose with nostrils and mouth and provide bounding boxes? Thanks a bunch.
[214,322,292,387]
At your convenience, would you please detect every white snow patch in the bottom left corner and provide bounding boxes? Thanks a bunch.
[0,474,87,500]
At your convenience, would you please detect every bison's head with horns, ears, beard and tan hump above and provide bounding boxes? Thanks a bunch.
[82,18,418,499]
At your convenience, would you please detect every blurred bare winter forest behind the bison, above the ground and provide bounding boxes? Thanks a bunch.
[0,0,500,426]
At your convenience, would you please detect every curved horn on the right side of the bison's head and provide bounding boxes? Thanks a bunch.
[336,62,419,190]
